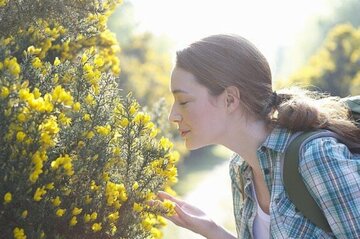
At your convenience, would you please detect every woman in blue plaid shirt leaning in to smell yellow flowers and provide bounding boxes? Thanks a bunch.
[159,35,360,239]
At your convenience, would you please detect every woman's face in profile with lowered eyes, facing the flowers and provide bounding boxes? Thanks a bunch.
[169,67,226,149]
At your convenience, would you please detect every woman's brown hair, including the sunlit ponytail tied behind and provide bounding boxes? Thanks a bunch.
[176,34,360,140]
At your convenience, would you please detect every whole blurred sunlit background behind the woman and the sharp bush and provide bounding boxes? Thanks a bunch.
[109,0,360,239]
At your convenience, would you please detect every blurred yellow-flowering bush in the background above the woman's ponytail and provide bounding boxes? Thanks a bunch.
[276,24,360,97]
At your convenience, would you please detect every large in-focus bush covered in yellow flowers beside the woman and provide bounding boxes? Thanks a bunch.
[0,0,178,239]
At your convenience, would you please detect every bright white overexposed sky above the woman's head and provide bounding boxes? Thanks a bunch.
[130,0,328,73]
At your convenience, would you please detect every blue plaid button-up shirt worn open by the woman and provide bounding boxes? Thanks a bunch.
[230,128,360,239]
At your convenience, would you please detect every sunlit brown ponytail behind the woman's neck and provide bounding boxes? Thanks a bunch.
[263,88,360,141]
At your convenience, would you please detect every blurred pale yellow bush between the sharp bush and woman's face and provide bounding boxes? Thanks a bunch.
[108,1,187,157]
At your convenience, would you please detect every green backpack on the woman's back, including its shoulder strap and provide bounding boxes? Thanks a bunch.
[283,95,360,232]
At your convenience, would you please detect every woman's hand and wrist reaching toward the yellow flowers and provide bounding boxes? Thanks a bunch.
[158,192,235,239]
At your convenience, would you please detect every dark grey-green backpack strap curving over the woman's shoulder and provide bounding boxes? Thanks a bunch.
[283,131,337,232]
